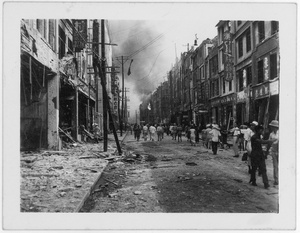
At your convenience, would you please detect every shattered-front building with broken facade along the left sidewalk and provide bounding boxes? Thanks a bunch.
[20,19,112,149]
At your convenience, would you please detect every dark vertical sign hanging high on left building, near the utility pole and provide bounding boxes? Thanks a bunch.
[72,19,87,52]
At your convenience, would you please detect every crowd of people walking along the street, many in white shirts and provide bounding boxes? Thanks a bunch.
[133,120,279,188]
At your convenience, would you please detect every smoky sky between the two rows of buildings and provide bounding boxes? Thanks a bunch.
[108,20,218,122]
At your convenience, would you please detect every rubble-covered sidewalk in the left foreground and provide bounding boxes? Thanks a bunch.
[20,137,129,213]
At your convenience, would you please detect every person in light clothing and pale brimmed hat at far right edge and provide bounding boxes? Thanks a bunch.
[267,120,279,185]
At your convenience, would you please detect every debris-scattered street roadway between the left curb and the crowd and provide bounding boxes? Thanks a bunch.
[81,134,279,213]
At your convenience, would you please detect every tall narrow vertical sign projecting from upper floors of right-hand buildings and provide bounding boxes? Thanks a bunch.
[223,30,233,81]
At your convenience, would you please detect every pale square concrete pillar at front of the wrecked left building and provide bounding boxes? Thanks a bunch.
[47,75,60,150]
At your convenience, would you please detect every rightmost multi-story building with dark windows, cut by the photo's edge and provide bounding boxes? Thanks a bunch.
[252,21,279,127]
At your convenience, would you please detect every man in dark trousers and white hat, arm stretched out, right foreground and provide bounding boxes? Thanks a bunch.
[249,125,270,189]
